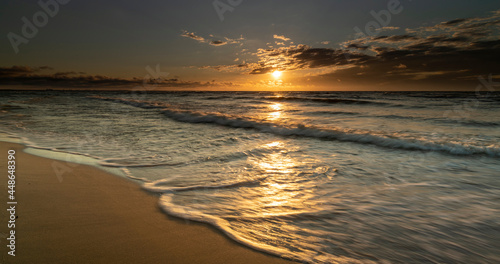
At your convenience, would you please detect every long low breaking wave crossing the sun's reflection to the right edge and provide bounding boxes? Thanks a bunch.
[94,98,500,157]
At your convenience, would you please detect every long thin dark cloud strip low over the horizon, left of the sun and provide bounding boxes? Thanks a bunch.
[0,66,229,90]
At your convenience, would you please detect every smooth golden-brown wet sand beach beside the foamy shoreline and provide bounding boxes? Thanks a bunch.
[0,142,294,263]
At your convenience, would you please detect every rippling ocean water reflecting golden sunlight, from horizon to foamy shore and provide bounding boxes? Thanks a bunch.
[0,91,500,263]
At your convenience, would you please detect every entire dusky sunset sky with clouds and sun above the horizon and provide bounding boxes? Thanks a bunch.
[0,0,500,91]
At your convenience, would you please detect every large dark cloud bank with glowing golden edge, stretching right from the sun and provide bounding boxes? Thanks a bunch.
[198,11,500,89]
